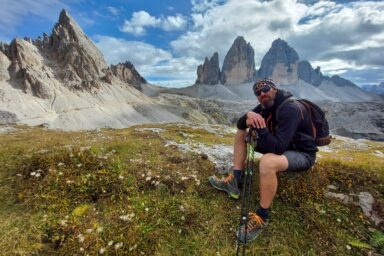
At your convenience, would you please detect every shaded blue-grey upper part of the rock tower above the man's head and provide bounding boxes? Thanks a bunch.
[258,38,299,78]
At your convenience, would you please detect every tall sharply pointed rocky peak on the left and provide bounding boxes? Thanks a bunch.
[49,10,107,89]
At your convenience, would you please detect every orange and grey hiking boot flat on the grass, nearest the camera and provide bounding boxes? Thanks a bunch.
[236,212,268,244]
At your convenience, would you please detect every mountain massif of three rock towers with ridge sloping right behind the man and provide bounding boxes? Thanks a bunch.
[195,36,378,101]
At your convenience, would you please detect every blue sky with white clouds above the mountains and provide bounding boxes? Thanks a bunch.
[0,0,384,87]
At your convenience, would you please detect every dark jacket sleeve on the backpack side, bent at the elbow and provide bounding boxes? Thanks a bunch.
[256,104,302,155]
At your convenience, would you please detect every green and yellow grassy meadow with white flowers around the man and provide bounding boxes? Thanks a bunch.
[0,124,384,255]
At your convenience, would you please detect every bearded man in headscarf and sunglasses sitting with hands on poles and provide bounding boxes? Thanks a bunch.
[209,79,318,242]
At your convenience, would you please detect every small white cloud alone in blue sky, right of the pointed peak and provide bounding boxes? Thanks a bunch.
[120,11,187,36]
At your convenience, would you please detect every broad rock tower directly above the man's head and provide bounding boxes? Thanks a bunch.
[258,38,299,84]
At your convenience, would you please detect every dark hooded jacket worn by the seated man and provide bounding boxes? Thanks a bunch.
[237,89,318,155]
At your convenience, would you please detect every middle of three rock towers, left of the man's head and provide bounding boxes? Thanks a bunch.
[220,36,256,84]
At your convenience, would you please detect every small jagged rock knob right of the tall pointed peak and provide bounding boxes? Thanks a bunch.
[106,61,147,91]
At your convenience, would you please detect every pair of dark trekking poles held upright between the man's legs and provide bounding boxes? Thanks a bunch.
[236,128,257,255]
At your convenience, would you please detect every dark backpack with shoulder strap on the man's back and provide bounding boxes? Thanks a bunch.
[276,98,332,146]
